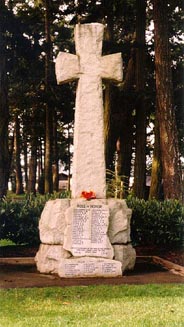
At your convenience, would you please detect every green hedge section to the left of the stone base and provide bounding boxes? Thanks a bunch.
[0,193,68,246]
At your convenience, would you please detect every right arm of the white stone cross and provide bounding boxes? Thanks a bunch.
[101,53,123,82]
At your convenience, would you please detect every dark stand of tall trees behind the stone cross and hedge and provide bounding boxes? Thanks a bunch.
[0,0,184,199]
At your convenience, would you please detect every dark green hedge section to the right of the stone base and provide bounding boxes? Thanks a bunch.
[127,197,184,246]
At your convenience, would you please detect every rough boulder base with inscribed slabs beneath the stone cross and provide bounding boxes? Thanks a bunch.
[35,199,136,278]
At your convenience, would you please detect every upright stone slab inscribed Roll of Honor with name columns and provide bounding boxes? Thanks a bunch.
[63,200,114,259]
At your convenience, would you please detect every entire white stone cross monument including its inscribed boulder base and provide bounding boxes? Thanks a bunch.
[35,23,136,278]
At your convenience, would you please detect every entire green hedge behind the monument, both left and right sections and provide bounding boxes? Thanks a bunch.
[0,192,184,247]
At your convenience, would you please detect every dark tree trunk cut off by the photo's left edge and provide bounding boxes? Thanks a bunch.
[0,0,10,199]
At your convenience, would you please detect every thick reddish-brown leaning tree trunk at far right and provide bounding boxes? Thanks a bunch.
[153,0,182,200]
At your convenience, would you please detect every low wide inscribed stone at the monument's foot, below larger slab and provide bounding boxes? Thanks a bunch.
[58,257,122,278]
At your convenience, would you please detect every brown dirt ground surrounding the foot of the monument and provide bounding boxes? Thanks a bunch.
[0,247,184,288]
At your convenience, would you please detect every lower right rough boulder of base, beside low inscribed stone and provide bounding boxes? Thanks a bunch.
[113,244,136,272]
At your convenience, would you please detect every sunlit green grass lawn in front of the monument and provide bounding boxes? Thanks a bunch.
[0,284,184,327]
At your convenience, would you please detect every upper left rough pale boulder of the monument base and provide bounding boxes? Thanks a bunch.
[39,199,70,245]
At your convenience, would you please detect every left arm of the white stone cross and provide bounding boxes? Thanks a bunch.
[56,52,80,84]
